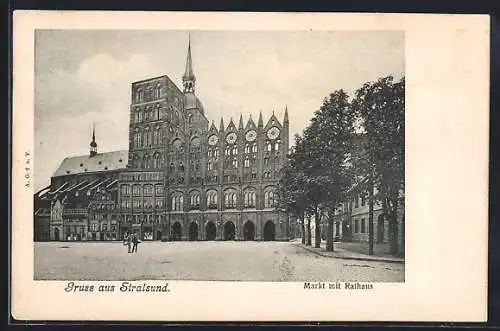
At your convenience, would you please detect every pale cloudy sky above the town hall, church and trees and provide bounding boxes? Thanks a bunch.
[34,30,405,191]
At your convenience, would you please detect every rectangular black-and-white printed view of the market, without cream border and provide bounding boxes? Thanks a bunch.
[33,30,405,282]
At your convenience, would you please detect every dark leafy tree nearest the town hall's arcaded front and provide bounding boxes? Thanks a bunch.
[290,90,354,251]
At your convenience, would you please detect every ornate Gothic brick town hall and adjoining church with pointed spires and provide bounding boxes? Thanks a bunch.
[35,37,289,240]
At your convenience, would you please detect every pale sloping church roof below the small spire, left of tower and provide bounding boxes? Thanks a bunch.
[54,150,128,177]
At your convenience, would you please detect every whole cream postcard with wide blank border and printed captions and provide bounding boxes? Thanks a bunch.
[11,11,489,321]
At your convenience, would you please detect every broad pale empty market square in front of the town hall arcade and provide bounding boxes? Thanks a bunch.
[34,241,404,282]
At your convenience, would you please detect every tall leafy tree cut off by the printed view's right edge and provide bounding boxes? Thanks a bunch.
[352,76,405,254]
